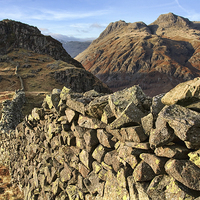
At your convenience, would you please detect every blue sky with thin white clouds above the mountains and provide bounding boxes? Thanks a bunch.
[0,0,200,40]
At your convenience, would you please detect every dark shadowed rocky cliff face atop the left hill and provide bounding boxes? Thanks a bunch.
[0,20,82,68]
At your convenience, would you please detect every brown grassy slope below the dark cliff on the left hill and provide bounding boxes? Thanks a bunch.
[0,49,77,115]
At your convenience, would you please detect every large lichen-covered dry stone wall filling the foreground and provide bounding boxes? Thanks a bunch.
[1,78,200,200]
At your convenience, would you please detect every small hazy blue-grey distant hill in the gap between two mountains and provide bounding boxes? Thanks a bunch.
[63,41,91,58]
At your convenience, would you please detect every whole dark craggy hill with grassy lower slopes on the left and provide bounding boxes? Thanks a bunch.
[0,20,111,115]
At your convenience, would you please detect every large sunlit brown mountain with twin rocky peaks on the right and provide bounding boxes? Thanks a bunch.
[75,13,200,96]
